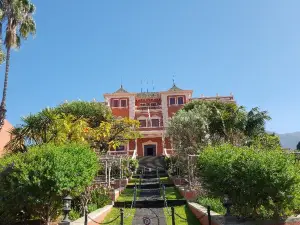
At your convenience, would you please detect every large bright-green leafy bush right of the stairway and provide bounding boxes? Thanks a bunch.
[199,145,300,218]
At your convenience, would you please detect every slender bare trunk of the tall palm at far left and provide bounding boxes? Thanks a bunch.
[0,47,10,131]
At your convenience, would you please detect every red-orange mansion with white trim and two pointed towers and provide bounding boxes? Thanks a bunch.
[104,84,235,157]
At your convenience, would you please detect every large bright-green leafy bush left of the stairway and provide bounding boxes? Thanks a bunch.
[0,143,99,221]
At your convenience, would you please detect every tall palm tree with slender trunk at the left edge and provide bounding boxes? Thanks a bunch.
[0,0,36,131]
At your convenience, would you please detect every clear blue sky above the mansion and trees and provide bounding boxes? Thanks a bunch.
[0,0,300,133]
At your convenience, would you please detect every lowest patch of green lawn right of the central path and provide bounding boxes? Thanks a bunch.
[164,205,200,225]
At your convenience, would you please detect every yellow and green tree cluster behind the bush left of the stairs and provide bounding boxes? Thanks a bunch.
[5,101,140,152]
